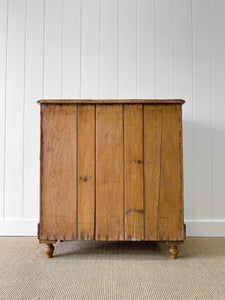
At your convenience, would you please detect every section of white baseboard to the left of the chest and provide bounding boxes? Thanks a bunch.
[0,219,38,236]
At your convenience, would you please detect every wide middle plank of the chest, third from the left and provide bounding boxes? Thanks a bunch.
[96,104,124,240]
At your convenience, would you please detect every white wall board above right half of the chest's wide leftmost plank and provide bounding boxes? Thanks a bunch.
[61,0,81,99]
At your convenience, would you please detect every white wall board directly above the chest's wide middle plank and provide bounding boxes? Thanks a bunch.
[99,0,118,99]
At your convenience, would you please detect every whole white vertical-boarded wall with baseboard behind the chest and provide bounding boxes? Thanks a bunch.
[0,0,225,236]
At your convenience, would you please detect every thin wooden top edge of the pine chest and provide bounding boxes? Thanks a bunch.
[37,99,185,104]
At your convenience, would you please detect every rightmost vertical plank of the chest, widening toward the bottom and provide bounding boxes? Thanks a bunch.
[158,105,184,241]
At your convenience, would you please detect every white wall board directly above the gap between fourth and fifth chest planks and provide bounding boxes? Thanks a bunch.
[137,0,156,99]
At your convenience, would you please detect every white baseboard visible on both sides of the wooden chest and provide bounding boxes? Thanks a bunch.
[0,219,225,237]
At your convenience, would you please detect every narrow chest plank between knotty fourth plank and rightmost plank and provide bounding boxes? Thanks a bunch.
[144,105,162,240]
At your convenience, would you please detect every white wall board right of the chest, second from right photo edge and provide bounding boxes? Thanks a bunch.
[192,0,213,219]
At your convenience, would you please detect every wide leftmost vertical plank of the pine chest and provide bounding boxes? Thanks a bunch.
[40,104,77,240]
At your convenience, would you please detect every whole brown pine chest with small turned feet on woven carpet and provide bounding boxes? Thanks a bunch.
[38,100,185,258]
